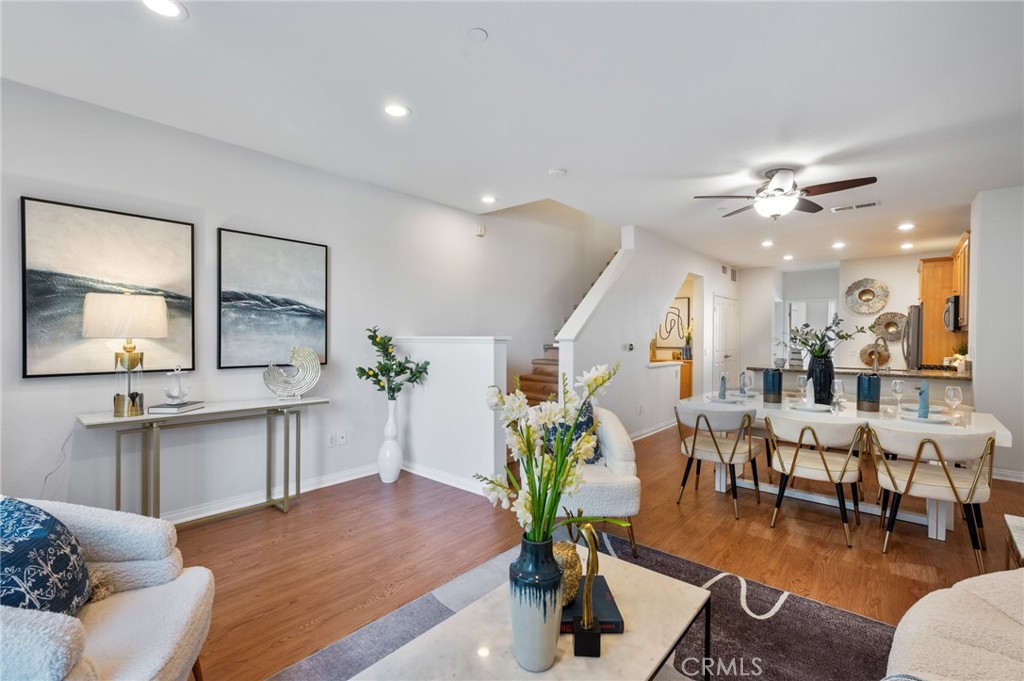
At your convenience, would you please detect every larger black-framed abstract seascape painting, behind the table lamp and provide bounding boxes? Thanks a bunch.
[20,197,196,378]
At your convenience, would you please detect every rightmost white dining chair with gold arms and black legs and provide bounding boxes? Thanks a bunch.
[869,422,995,573]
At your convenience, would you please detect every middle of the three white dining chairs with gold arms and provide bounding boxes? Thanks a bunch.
[765,414,864,548]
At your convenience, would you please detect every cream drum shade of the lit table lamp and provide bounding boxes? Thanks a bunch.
[82,293,167,338]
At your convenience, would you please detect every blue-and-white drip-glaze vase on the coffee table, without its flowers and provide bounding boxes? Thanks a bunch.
[509,536,562,672]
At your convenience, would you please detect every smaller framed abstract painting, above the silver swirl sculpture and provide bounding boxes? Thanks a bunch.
[217,228,327,369]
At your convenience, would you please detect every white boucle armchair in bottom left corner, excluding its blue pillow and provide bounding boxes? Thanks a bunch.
[0,500,213,681]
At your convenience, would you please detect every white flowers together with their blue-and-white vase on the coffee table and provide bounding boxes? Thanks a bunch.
[474,364,628,672]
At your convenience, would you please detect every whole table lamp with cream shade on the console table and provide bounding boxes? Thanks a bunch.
[82,292,167,417]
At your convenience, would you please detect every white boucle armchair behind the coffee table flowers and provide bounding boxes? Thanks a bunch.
[562,407,640,556]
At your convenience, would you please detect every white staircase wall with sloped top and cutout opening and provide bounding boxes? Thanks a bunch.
[558,226,738,437]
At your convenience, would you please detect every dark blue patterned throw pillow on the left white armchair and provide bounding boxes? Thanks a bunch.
[0,497,92,616]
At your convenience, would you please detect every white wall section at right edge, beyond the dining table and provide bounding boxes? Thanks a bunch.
[969,186,1024,481]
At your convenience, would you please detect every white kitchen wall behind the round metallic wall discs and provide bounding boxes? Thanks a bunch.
[835,253,949,369]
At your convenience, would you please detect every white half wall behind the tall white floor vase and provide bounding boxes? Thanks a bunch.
[391,337,508,495]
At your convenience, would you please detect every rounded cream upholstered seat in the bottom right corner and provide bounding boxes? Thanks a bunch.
[887,568,1024,681]
